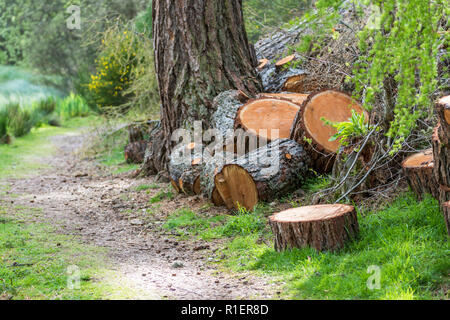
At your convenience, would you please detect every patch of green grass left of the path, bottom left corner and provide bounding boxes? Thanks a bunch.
[0,206,146,300]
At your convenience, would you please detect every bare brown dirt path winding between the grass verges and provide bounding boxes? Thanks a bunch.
[2,129,275,299]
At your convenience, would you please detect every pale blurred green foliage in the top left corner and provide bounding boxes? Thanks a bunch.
[0,0,148,85]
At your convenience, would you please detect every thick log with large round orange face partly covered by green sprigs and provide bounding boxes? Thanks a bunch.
[290,90,368,173]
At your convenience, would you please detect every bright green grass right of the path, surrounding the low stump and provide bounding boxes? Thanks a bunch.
[164,194,450,299]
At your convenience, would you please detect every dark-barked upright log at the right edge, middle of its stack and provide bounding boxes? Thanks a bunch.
[432,124,450,204]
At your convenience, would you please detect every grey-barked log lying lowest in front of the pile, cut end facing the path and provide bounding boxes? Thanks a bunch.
[214,139,310,210]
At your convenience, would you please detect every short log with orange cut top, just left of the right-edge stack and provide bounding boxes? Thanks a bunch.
[402,149,439,200]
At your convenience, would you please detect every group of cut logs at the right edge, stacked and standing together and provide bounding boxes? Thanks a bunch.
[402,96,450,235]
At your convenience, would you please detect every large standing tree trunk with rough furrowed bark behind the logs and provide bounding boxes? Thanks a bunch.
[153,0,261,167]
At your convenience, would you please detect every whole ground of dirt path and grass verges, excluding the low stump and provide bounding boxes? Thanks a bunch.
[0,119,450,300]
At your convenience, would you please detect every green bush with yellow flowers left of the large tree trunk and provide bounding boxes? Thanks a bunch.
[88,27,139,113]
